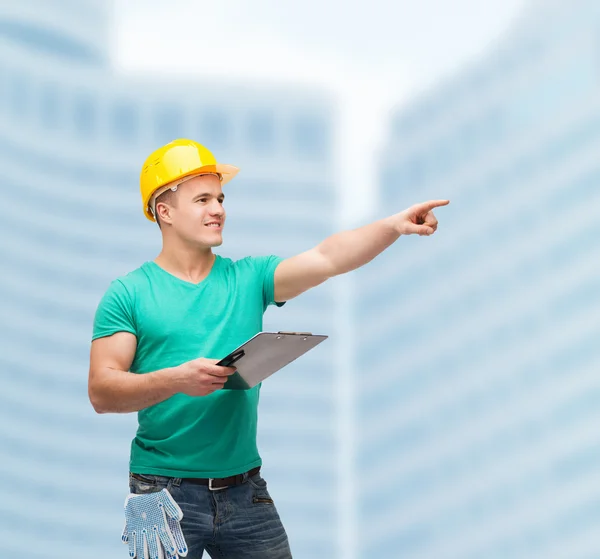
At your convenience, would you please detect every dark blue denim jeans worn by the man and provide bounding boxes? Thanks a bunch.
[129,472,292,559]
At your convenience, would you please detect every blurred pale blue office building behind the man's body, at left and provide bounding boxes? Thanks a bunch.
[0,0,337,559]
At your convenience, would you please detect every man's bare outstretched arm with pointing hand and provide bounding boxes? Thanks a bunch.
[275,200,449,302]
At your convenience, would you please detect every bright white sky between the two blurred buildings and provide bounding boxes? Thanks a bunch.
[114,0,527,223]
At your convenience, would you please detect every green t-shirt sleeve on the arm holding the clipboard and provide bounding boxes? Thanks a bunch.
[92,280,137,340]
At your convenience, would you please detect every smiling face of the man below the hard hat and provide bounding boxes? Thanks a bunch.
[156,175,225,247]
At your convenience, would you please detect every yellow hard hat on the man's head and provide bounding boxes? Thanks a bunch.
[140,139,239,221]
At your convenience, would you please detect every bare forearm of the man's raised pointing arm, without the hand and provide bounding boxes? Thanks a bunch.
[316,217,400,276]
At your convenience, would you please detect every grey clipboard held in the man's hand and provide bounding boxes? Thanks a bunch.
[216,332,329,390]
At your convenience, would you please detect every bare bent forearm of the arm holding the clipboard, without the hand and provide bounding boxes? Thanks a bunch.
[88,368,178,413]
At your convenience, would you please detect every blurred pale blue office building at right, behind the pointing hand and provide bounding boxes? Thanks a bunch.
[354,1,600,559]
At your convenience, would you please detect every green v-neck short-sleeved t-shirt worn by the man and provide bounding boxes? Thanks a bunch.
[92,255,283,478]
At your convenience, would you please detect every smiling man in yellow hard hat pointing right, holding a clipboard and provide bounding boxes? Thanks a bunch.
[89,140,448,559]
